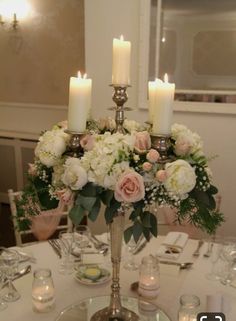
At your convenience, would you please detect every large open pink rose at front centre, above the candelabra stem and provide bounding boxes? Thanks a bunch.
[115,171,145,203]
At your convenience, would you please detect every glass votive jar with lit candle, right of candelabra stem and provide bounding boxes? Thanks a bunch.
[138,255,160,299]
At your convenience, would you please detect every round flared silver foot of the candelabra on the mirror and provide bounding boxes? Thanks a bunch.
[90,307,140,321]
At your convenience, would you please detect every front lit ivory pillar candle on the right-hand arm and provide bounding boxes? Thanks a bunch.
[149,74,175,135]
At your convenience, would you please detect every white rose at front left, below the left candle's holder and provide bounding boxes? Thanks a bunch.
[62,157,88,190]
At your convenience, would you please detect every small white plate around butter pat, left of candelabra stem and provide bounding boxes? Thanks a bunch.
[75,264,111,285]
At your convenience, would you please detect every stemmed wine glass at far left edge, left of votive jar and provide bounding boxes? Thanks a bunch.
[1,249,20,302]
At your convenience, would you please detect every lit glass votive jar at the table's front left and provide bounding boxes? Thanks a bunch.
[32,269,55,312]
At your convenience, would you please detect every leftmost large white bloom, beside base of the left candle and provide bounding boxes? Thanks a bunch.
[35,128,69,167]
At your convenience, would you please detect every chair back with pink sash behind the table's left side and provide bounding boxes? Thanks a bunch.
[8,189,72,246]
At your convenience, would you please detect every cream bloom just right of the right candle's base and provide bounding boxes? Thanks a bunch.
[171,124,203,156]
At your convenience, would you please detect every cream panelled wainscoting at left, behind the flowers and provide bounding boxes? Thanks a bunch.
[0,102,67,203]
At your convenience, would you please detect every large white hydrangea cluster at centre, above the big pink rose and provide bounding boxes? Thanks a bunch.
[81,132,134,187]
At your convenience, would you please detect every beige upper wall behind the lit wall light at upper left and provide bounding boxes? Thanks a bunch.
[0,0,84,105]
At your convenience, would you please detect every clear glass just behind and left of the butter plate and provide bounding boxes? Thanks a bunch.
[59,231,74,274]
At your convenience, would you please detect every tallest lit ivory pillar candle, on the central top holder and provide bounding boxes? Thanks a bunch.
[112,36,131,85]
